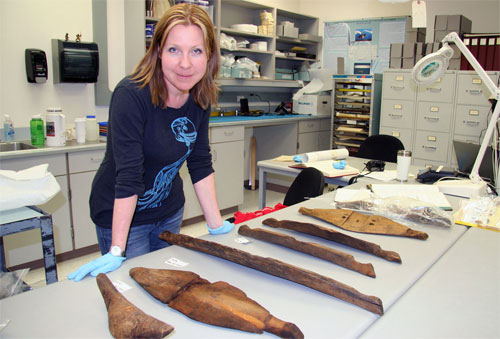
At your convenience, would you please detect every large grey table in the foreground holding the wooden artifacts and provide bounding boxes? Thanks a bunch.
[0,192,474,339]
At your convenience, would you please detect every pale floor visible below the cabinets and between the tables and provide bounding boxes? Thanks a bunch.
[24,190,285,288]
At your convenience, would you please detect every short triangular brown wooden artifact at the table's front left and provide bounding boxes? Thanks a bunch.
[96,273,174,338]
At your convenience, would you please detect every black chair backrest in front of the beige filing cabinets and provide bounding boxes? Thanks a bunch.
[354,134,405,162]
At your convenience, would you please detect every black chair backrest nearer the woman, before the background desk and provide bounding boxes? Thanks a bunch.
[283,167,325,206]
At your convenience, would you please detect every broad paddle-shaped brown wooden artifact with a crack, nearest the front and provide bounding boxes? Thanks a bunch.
[130,267,304,338]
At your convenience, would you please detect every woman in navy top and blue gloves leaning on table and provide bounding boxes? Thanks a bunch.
[68,4,234,281]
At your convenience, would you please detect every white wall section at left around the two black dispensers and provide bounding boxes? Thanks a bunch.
[0,0,107,135]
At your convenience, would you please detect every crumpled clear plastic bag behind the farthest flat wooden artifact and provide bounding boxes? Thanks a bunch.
[335,193,454,227]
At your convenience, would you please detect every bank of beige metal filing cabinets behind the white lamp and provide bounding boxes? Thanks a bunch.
[380,69,500,166]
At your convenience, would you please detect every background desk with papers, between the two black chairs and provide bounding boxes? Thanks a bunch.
[257,157,410,210]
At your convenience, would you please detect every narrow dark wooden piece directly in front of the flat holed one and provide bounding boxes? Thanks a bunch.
[262,218,401,263]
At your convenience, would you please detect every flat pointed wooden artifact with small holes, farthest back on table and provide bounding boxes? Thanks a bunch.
[299,207,429,240]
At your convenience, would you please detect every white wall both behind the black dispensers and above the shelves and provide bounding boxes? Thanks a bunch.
[0,0,500,133]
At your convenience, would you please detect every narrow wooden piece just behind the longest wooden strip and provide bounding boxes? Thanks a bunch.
[238,225,375,278]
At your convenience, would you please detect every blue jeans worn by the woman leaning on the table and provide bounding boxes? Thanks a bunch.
[96,207,184,259]
